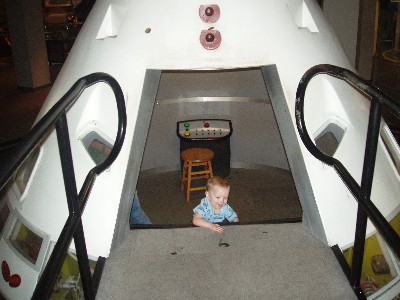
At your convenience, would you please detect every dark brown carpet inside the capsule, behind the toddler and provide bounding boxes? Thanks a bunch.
[137,167,302,226]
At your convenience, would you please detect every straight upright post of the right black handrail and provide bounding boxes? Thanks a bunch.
[350,97,381,290]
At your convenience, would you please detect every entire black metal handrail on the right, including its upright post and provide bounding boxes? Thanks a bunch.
[295,64,400,294]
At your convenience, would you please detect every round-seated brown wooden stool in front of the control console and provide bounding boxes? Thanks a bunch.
[181,148,214,202]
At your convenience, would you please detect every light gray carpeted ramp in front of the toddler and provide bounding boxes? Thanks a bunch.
[96,223,356,300]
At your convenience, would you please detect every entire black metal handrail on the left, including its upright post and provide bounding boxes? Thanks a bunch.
[0,73,127,299]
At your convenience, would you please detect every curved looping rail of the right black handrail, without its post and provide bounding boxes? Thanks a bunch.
[295,64,400,258]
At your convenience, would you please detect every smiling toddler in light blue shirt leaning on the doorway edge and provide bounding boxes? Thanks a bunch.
[192,176,239,233]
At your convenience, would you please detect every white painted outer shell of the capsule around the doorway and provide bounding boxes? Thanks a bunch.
[2,4,400,298]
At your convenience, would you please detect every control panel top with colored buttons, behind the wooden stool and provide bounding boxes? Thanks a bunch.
[177,119,232,140]
